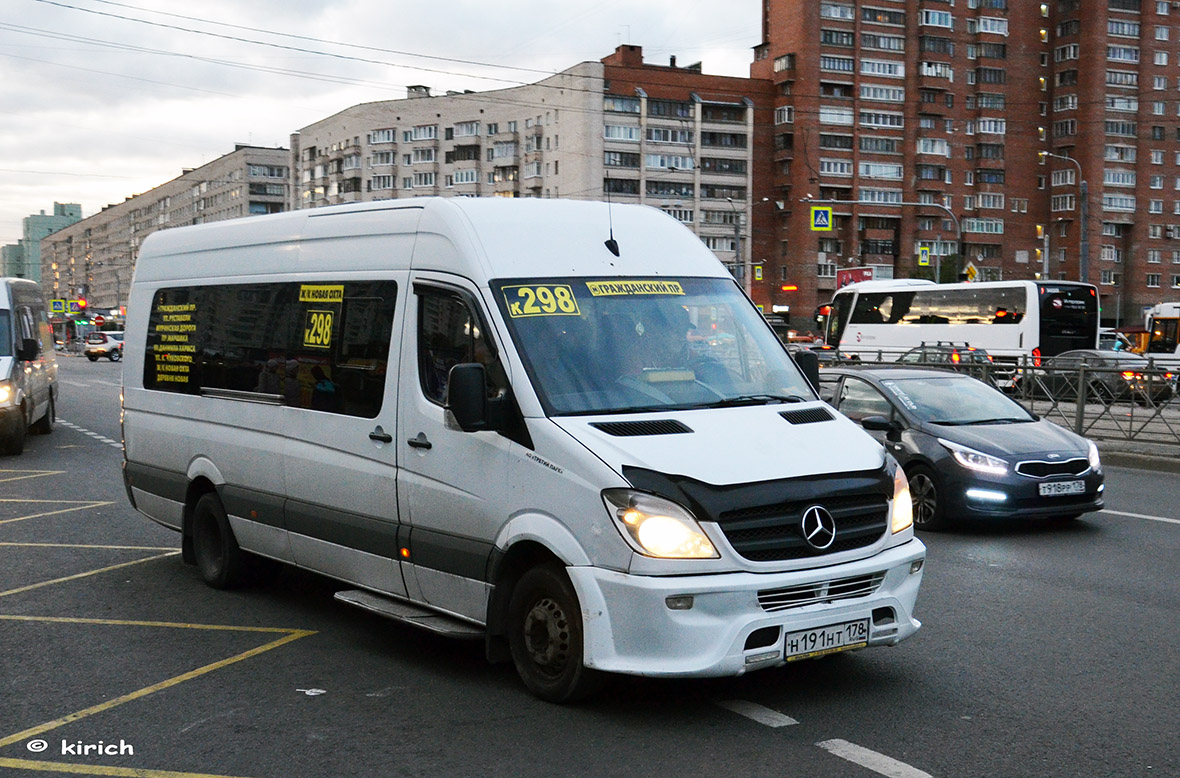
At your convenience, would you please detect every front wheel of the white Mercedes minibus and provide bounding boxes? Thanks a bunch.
[507,564,602,702]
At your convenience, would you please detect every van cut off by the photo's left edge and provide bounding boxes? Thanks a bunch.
[0,279,58,453]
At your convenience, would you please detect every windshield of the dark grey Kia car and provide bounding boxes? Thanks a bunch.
[881,375,1036,425]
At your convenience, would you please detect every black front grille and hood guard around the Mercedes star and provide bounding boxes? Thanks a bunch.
[623,465,893,562]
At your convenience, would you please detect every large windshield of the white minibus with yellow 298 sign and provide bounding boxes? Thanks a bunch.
[492,279,815,416]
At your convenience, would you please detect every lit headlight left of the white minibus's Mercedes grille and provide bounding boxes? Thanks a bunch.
[602,489,721,560]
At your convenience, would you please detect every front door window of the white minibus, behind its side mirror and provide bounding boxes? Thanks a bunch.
[418,289,507,405]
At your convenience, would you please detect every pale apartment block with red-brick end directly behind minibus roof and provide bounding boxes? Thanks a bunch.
[290,45,775,303]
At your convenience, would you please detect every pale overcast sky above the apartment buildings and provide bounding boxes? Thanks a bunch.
[0,0,762,244]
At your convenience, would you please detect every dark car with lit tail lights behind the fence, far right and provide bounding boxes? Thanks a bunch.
[1038,348,1175,405]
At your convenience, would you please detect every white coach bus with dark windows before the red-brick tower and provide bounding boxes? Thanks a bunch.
[817,279,1099,365]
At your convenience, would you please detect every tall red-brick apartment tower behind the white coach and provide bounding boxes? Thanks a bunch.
[750,0,1180,322]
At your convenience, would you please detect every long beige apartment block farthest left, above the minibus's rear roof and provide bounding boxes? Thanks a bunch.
[40,145,290,309]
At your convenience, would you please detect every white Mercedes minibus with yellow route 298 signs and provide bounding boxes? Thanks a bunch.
[123,197,925,701]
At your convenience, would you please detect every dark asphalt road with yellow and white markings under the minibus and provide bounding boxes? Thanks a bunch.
[0,358,1180,778]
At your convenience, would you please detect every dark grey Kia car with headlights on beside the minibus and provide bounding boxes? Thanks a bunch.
[821,366,1103,530]
